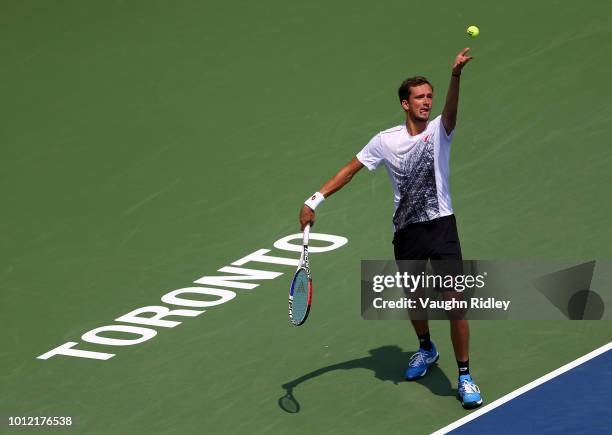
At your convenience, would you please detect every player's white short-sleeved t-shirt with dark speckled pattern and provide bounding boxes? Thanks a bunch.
[357,116,454,231]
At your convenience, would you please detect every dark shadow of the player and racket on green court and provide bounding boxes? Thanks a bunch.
[278,346,457,413]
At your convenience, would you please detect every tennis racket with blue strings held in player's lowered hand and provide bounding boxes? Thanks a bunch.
[289,224,312,326]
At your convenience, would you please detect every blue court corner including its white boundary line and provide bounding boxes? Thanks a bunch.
[436,343,612,434]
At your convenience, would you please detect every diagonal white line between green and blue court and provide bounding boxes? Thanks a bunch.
[432,342,612,435]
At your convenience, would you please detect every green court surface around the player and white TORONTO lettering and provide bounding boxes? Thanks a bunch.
[0,0,612,434]
